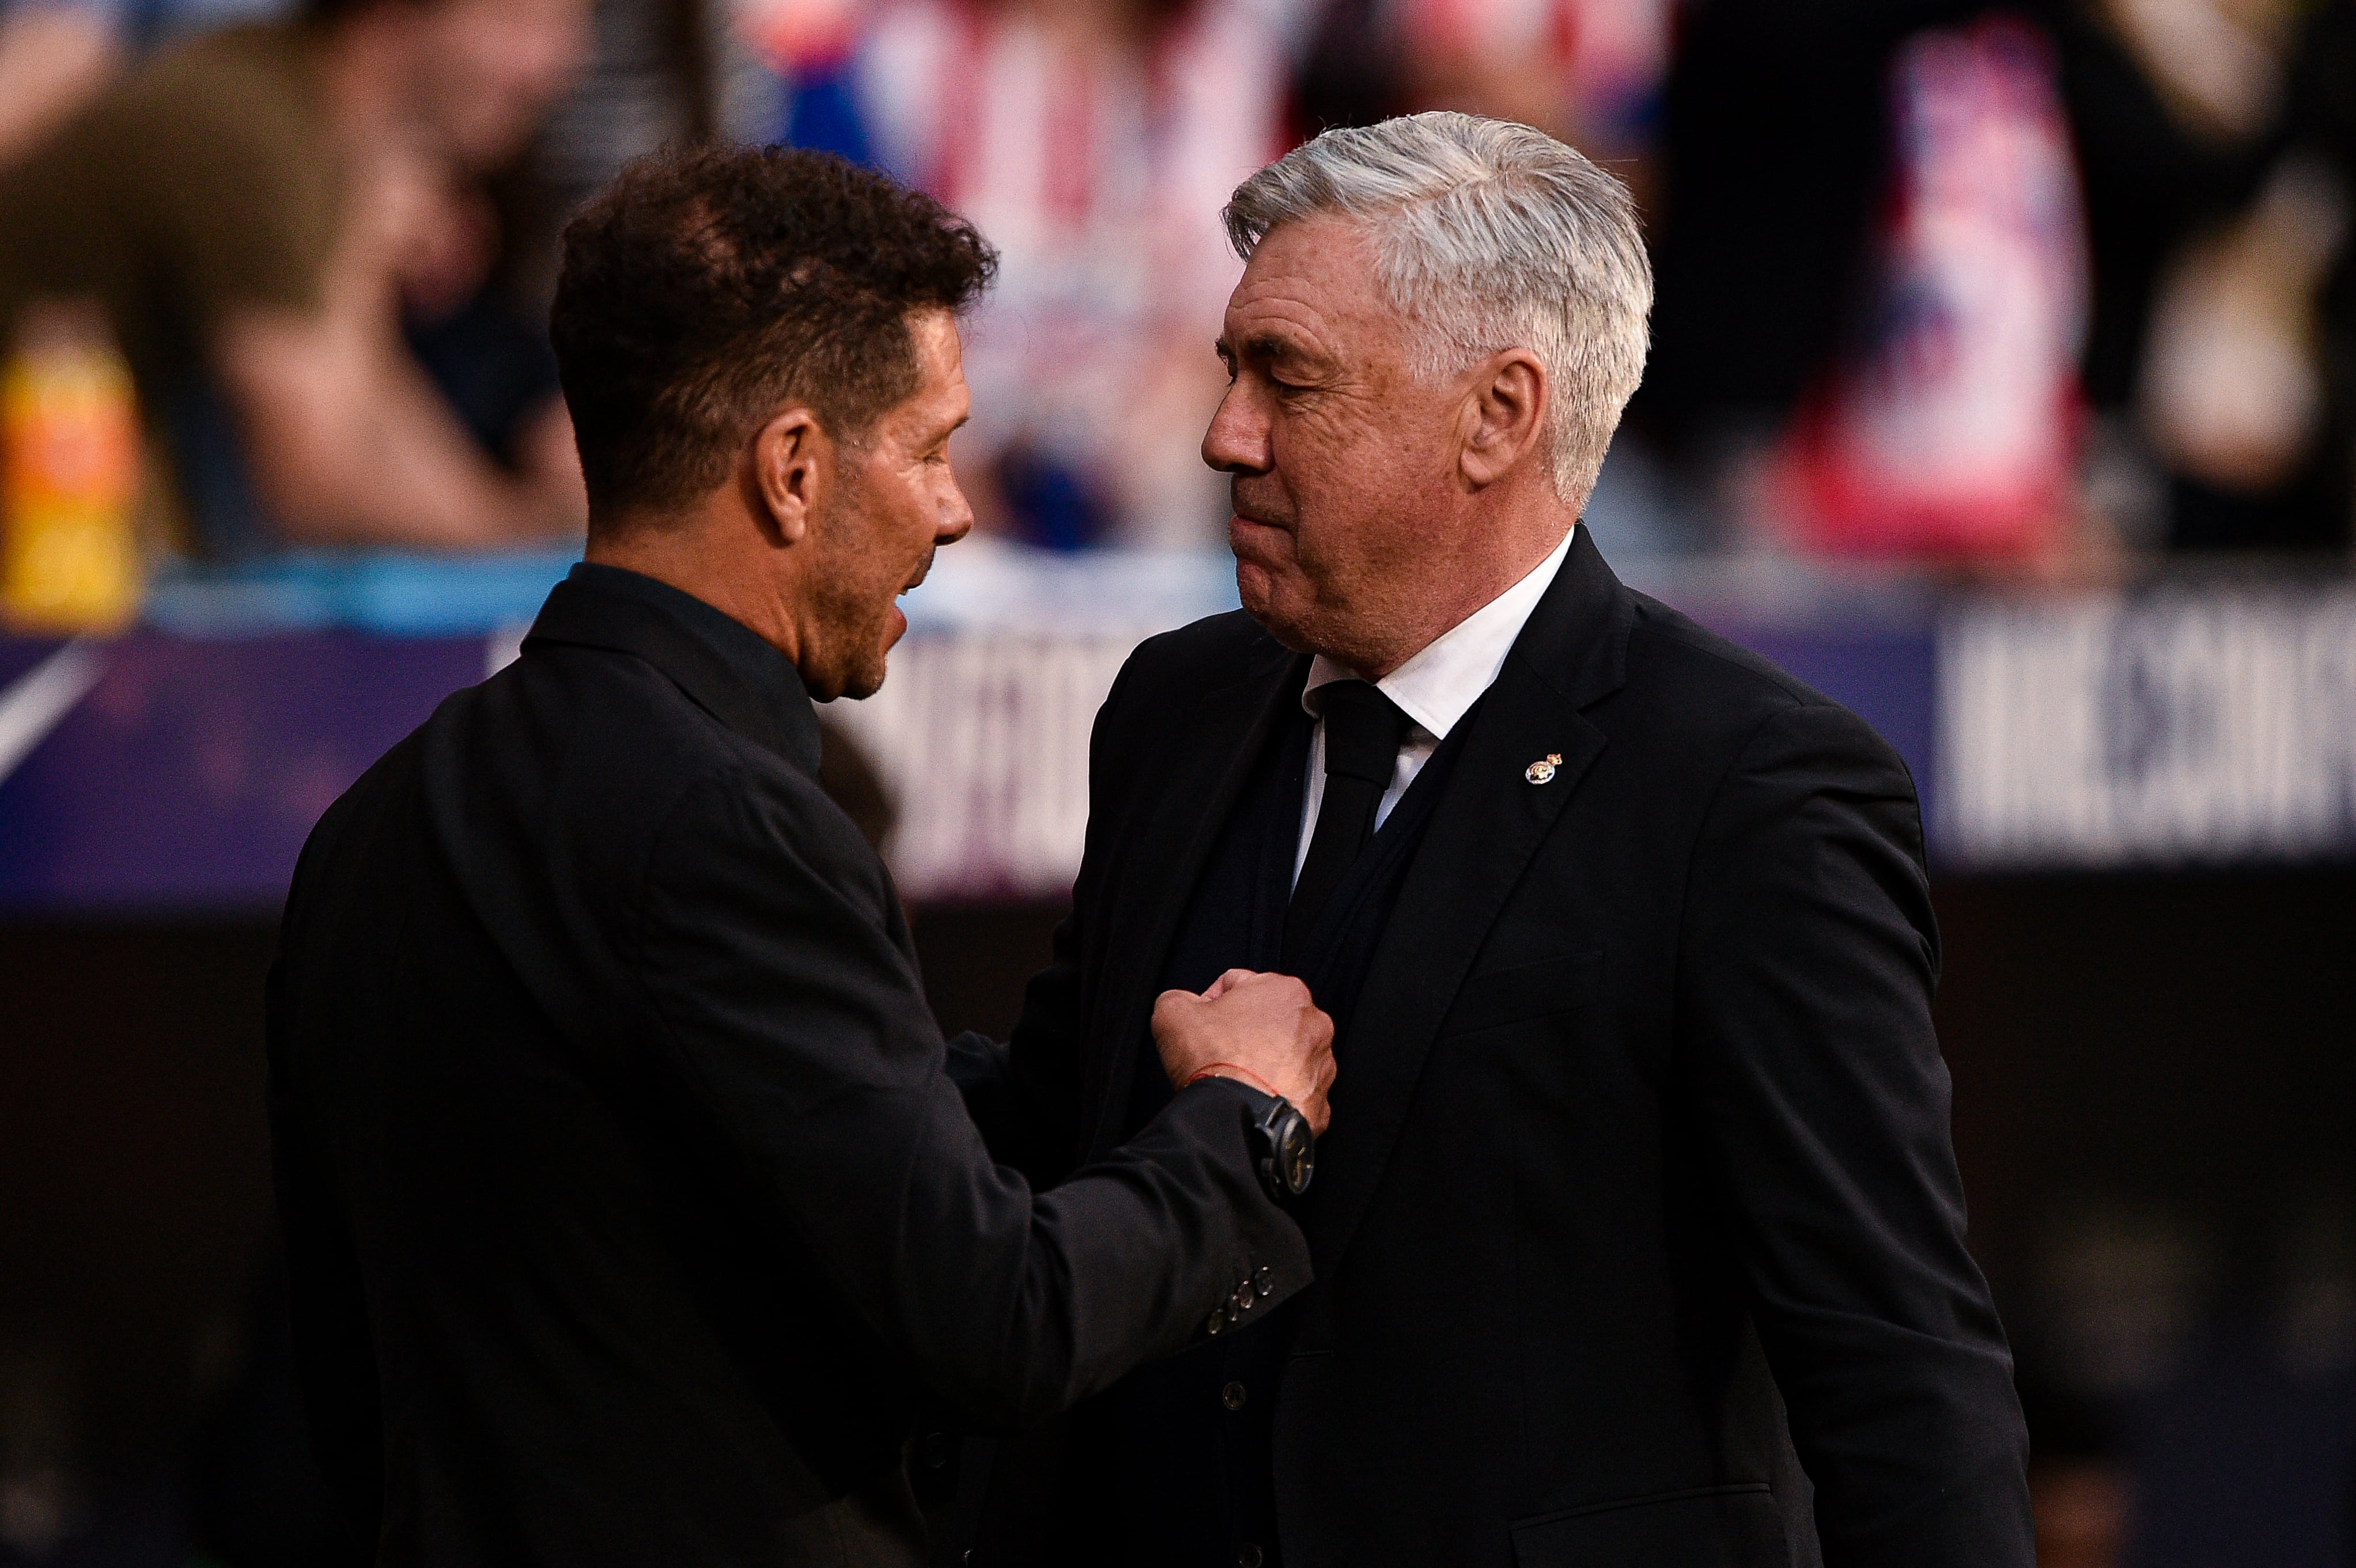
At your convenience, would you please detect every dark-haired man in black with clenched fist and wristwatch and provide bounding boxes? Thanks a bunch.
[271,151,1333,1568]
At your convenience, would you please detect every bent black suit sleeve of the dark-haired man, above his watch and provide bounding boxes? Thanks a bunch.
[636,770,1310,1422]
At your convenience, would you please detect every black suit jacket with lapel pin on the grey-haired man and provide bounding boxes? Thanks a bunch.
[956,530,2031,1568]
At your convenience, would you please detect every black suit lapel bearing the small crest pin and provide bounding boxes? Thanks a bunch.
[1303,528,1633,1278]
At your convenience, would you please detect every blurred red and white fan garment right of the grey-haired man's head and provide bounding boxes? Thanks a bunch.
[1765,14,2085,563]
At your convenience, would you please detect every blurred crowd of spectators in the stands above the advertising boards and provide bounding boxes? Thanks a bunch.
[0,0,2356,570]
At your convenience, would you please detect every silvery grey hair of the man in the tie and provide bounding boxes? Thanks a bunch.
[1220,111,1651,509]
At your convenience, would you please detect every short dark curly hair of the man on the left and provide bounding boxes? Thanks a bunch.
[549,146,999,528]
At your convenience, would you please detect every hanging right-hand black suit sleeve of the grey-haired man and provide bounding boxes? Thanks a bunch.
[1677,704,2033,1568]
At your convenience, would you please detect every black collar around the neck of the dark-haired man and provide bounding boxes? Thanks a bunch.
[523,560,820,777]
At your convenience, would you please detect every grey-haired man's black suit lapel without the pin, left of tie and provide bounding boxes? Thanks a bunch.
[1081,643,1307,1158]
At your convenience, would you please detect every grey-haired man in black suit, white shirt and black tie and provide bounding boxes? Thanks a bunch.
[959,113,2033,1568]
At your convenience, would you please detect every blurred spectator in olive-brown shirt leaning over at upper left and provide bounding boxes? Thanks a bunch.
[0,0,584,556]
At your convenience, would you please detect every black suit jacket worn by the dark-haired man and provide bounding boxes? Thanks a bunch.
[271,567,1307,1568]
